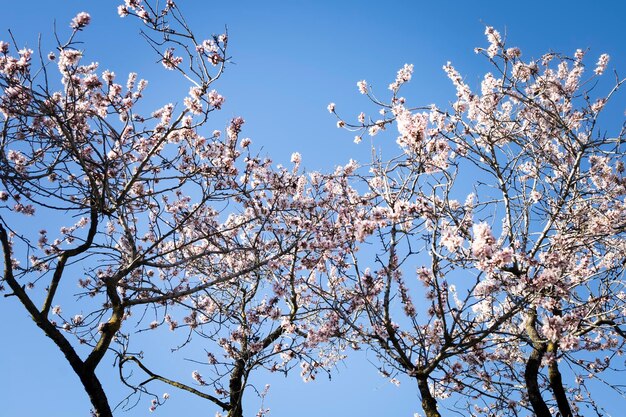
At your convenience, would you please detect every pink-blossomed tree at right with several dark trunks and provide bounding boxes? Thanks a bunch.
[325,27,626,417]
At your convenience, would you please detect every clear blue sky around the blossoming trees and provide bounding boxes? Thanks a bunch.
[0,0,626,417]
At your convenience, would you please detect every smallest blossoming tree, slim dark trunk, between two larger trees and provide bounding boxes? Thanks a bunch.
[117,159,359,417]
